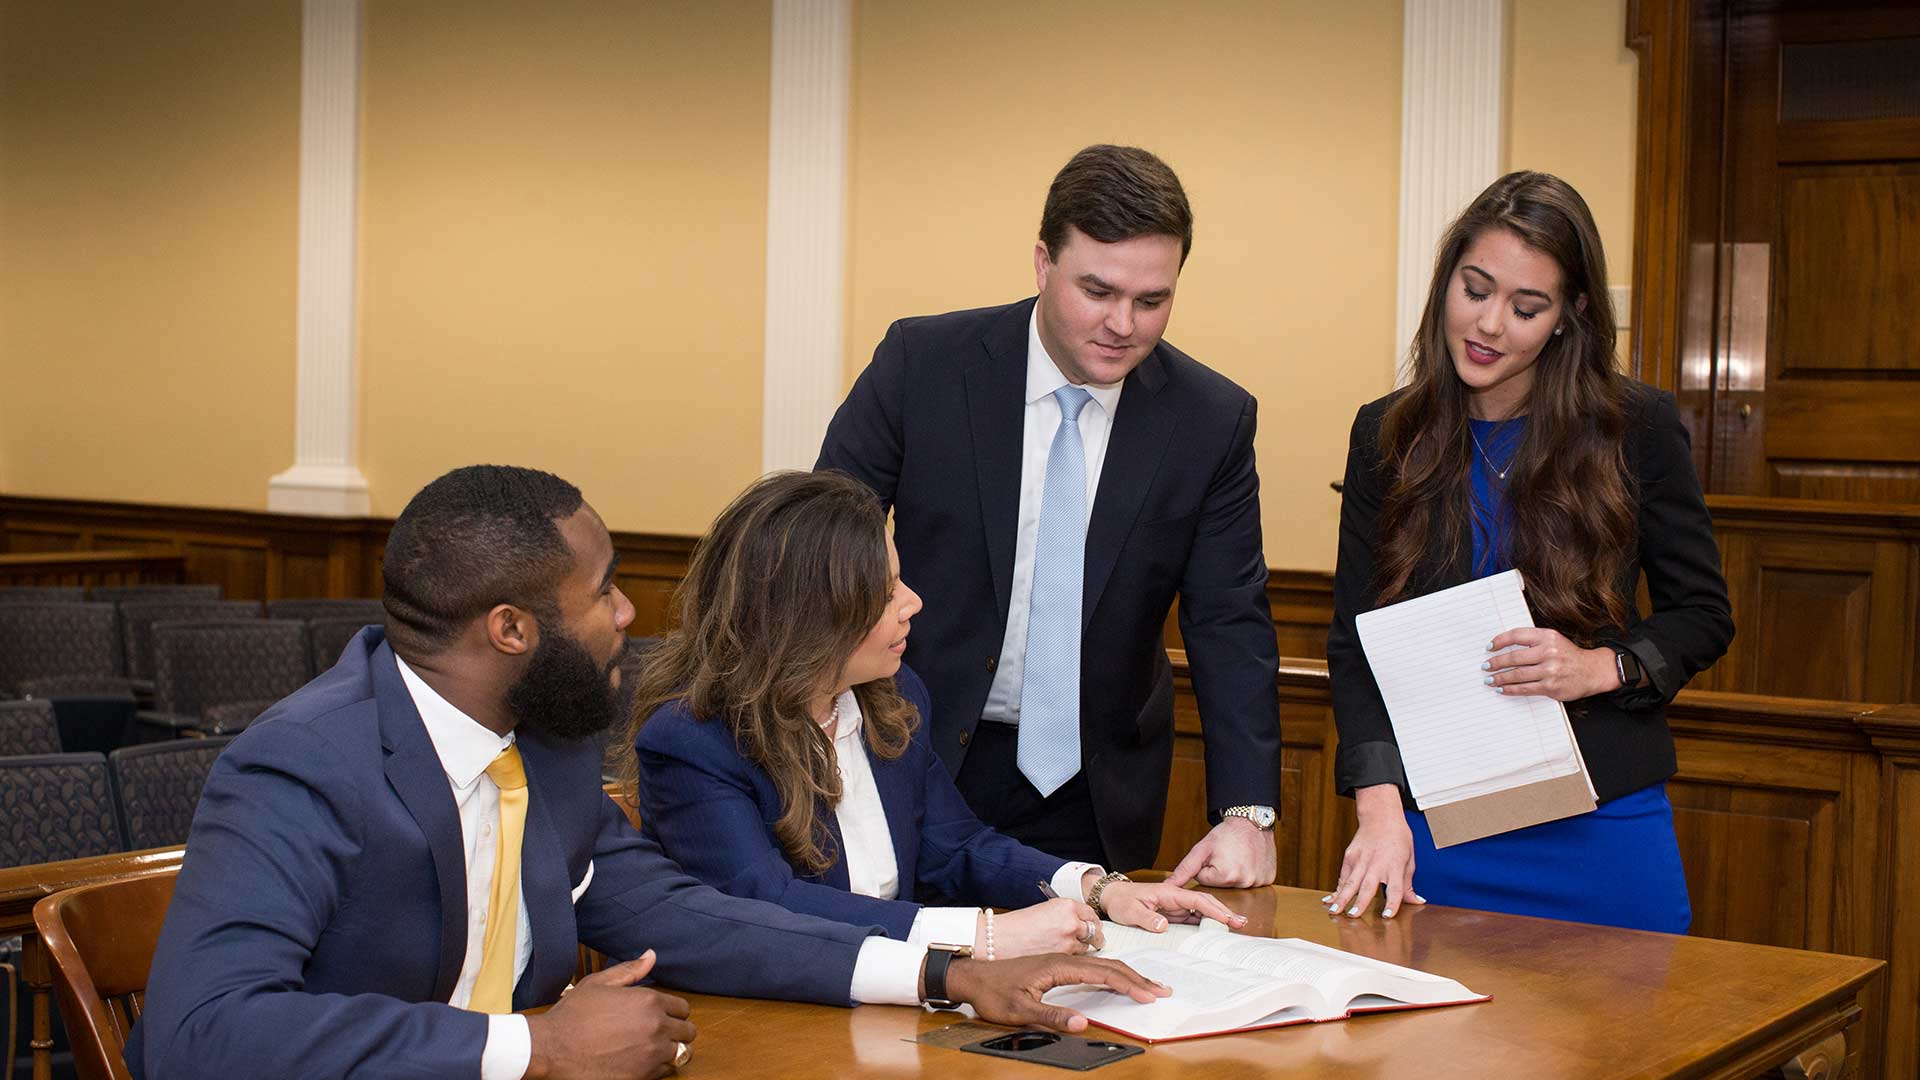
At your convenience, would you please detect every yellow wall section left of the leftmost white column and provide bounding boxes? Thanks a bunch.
[0,0,300,509]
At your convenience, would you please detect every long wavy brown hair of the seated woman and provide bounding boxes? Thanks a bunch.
[616,473,920,874]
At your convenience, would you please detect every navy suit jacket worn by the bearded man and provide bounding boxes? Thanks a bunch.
[127,626,874,1078]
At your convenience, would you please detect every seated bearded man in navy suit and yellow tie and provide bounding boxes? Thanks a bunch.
[127,465,1165,1080]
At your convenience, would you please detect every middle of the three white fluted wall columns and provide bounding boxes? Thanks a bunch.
[760,0,852,469]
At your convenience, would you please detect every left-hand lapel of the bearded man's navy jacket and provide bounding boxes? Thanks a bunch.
[369,642,467,1001]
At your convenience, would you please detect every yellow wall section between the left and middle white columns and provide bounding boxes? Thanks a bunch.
[361,0,772,532]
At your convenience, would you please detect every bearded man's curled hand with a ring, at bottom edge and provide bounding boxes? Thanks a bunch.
[526,949,693,1080]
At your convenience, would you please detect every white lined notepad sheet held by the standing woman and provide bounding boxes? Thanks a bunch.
[1356,571,1580,807]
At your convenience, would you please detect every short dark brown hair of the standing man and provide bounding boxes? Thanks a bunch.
[1041,142,1194,265]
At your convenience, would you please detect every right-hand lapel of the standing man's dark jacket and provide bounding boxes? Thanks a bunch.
[1081,346,1175,632]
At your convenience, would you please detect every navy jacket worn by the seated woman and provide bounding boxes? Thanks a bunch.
[634,667,1066,940]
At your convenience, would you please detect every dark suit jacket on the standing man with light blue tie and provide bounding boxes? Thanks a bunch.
[816,300,1281,869]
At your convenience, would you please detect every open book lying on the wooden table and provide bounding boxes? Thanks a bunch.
[1046,910,1488,1042]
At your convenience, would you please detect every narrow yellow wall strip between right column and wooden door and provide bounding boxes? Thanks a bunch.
[1507,0,1640,315]
